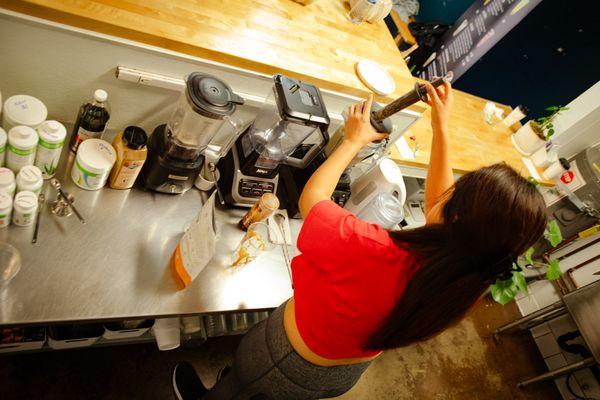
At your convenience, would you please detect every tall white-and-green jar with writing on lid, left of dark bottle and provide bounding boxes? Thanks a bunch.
[35,121,67,179]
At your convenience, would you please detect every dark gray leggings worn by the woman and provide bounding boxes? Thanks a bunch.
[203,303,370,400]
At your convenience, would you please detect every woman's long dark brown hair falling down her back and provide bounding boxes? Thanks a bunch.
[365,164,546,350]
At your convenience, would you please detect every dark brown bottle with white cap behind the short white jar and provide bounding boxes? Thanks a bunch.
[69,89,110,151]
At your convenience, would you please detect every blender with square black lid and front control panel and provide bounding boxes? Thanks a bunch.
[218,75,329,206]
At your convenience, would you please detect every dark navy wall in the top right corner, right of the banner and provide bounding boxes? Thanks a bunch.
[448,0,600,117]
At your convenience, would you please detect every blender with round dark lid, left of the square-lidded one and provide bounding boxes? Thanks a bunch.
[142,72,244,194]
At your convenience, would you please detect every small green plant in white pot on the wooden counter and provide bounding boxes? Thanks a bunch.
[511,106,569,156]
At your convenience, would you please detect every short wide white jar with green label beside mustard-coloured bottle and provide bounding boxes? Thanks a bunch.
[71,139,117,190]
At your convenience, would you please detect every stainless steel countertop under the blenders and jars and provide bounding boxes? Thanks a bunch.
[0,150,301,325]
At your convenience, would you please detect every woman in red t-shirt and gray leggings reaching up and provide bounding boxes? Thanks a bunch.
[173,83,546,400]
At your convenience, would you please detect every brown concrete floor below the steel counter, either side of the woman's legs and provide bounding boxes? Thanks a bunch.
[0,301,560,400]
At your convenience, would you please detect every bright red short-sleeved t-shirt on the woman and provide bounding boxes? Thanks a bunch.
[292,200,416,359]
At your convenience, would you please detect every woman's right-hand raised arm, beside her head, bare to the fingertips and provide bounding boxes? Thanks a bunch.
[425,82,454,224]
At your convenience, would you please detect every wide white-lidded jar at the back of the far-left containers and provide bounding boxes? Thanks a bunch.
[2,94,48,131]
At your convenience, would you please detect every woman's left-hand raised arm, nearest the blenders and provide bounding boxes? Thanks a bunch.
[298,95,387,218]
